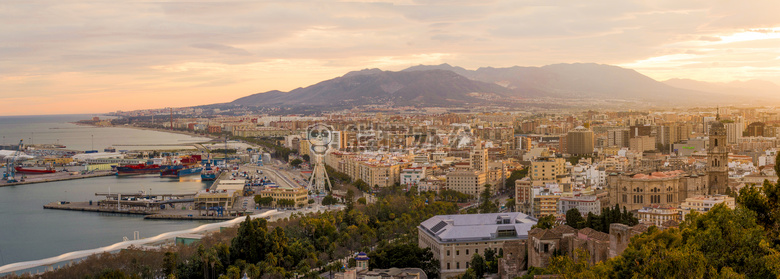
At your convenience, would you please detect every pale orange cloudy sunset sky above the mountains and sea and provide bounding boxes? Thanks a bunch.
[0,0,780,115]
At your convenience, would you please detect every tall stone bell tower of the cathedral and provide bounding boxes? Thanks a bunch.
[707,112,729,195]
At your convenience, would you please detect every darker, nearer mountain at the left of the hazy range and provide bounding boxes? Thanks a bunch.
[231,69,515,107]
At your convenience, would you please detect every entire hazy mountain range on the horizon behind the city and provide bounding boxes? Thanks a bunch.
[230,63,780,108]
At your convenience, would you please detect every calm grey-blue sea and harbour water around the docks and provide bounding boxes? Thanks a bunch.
[0,115,219,266]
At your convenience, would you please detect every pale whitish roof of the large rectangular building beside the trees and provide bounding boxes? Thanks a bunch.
[418,212,537,243]
